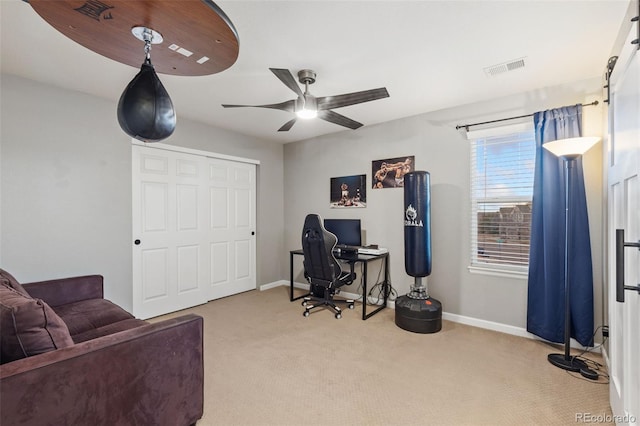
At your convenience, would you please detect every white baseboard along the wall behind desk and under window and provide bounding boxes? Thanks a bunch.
[260,280,608,350]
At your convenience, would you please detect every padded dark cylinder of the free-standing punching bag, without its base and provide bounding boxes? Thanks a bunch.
[404,171,431,277]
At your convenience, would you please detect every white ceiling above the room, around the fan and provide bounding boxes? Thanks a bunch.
[0,0,629,143]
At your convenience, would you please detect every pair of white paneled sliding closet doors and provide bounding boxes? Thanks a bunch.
[132,145,256,319]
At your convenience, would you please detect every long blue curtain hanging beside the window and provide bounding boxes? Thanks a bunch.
[527,105,593,346]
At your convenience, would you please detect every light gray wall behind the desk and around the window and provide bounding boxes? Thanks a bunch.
[283,79,602,329]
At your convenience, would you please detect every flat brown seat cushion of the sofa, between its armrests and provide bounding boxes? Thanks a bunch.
[53,299,134,337]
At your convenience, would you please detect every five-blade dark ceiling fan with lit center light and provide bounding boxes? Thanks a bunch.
[222,68,389,132]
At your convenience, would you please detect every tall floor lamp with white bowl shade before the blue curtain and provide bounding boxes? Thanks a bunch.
[542,137,600,371]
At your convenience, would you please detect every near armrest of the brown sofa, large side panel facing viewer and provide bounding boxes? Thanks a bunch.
[0,314,204,426]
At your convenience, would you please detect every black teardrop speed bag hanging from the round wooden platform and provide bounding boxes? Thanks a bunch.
[118,60,176,142]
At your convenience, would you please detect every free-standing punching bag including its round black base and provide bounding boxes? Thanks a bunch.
[395,171,442,333]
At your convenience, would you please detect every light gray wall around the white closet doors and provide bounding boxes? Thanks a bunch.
[0,74,284,311]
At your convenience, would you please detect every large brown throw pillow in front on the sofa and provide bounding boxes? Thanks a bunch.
[0,284,73,364]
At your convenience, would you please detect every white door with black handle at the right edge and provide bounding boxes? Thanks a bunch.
[607,11,640,425]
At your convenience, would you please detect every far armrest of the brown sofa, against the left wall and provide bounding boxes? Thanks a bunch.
[23,275,104,306]
